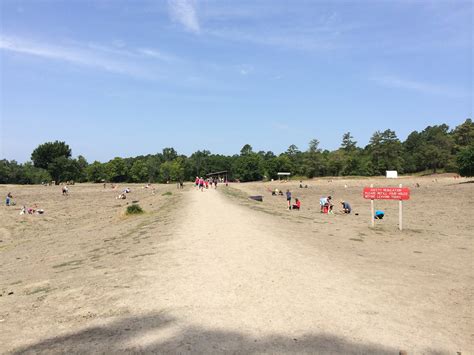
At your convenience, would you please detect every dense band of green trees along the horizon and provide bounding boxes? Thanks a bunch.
[0,119,474,184]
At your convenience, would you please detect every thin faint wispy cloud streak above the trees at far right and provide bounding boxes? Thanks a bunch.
[369,75,472,98]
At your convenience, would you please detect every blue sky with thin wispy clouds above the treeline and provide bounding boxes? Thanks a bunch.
[0,0,473,162]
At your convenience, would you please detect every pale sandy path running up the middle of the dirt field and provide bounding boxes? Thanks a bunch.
[10,185,470,354]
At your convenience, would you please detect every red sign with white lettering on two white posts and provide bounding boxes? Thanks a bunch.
[363,184,410,230]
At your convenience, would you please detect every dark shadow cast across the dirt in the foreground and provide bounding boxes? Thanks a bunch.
[12,313,412,354]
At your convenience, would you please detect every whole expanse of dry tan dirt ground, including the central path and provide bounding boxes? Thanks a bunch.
[0,177,474,354]
